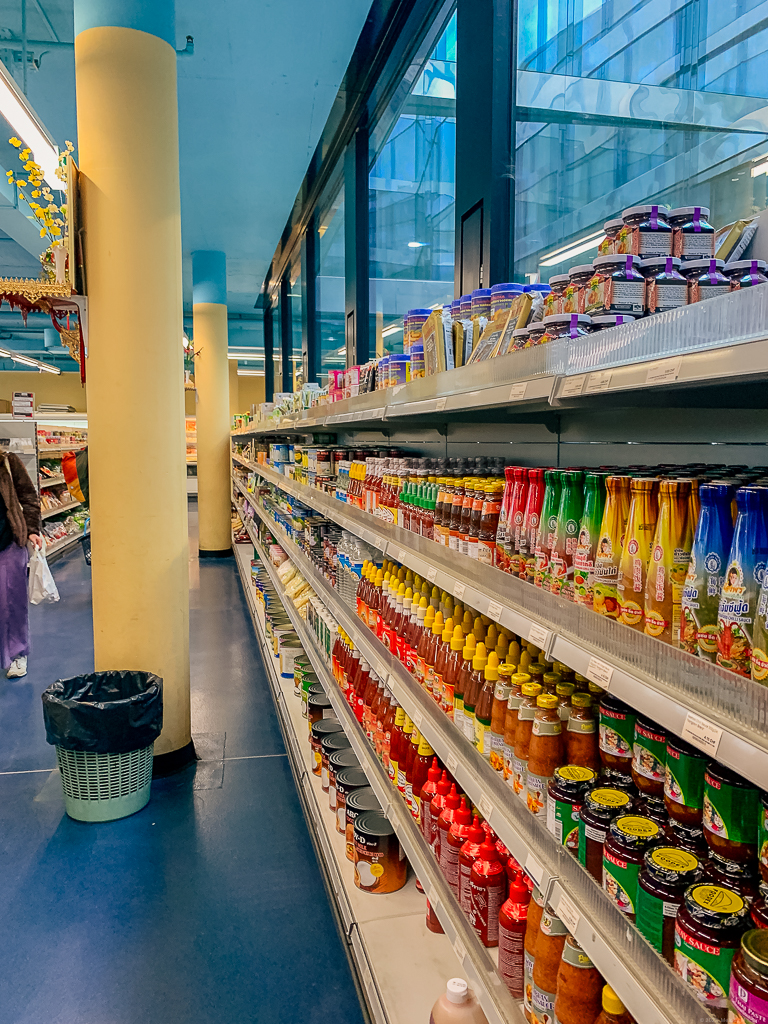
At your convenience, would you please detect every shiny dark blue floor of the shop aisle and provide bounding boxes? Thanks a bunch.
[0,513,362,1024]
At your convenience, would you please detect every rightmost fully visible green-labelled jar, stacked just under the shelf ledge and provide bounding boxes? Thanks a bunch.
[703,761,760,860]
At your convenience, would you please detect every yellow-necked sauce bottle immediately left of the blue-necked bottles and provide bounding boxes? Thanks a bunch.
[644,480,693,646]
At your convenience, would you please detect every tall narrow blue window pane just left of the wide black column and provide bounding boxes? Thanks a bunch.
[369,14,456,352]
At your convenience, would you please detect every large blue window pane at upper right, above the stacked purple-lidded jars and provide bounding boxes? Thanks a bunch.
[515,0,768,281]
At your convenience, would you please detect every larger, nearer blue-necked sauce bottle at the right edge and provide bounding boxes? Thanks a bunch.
[717,487,768,678]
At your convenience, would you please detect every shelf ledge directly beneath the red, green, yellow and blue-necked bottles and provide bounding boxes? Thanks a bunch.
[237,458,768,787]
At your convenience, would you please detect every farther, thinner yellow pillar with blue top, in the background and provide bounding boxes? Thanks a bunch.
[193,251,232,558]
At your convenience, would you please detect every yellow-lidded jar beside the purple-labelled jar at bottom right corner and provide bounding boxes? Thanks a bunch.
[675,882,750,1021]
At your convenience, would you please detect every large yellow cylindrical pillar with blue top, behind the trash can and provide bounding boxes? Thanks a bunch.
[75,0,194,770]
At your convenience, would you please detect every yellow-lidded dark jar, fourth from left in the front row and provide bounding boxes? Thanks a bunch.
[637,846,701,964]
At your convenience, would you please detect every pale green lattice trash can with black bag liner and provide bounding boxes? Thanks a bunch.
[43,672,163,821]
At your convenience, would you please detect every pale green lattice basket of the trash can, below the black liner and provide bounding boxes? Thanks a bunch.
[56,743,155,821]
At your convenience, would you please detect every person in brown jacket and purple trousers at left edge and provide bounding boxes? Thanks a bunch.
[0,453,43,679]
